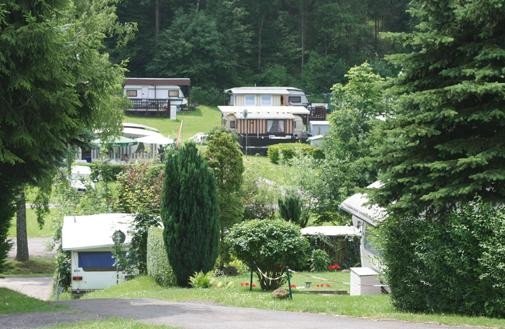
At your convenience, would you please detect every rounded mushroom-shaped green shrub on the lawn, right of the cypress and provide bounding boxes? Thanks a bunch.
[228,219,309,290]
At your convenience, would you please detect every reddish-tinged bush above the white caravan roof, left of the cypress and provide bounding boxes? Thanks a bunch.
[117,162,163,215]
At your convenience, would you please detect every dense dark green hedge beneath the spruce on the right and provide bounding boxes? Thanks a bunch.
[384,200,505,317]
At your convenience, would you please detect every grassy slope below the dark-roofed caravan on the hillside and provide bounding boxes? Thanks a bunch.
[123,105,221,140]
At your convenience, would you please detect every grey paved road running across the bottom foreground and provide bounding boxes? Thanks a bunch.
[0,299,488,329]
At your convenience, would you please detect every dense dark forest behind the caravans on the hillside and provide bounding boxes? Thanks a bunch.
[111,0,410,100]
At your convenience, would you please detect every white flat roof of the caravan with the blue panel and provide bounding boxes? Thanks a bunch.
[61,213,134,250]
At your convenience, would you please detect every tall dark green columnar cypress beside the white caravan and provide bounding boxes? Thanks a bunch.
[161,143,219,286]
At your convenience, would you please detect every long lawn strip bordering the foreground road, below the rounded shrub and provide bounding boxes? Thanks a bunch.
[84,273,505,328]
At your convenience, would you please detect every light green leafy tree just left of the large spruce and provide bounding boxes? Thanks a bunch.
[322,63,387,205]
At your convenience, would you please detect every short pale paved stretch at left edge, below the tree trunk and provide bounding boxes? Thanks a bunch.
[0,277,53,300]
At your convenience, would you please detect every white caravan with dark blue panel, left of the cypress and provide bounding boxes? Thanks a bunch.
[61,213,134,294]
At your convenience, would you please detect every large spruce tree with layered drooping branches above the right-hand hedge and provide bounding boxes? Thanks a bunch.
[377,0,505,214]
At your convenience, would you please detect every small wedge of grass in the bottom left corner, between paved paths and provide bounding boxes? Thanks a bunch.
[0,288,64,314]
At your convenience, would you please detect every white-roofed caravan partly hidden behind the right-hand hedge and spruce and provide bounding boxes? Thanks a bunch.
[340,181,386,273]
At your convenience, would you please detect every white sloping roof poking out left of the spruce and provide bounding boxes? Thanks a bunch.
[340,181,386,226]
